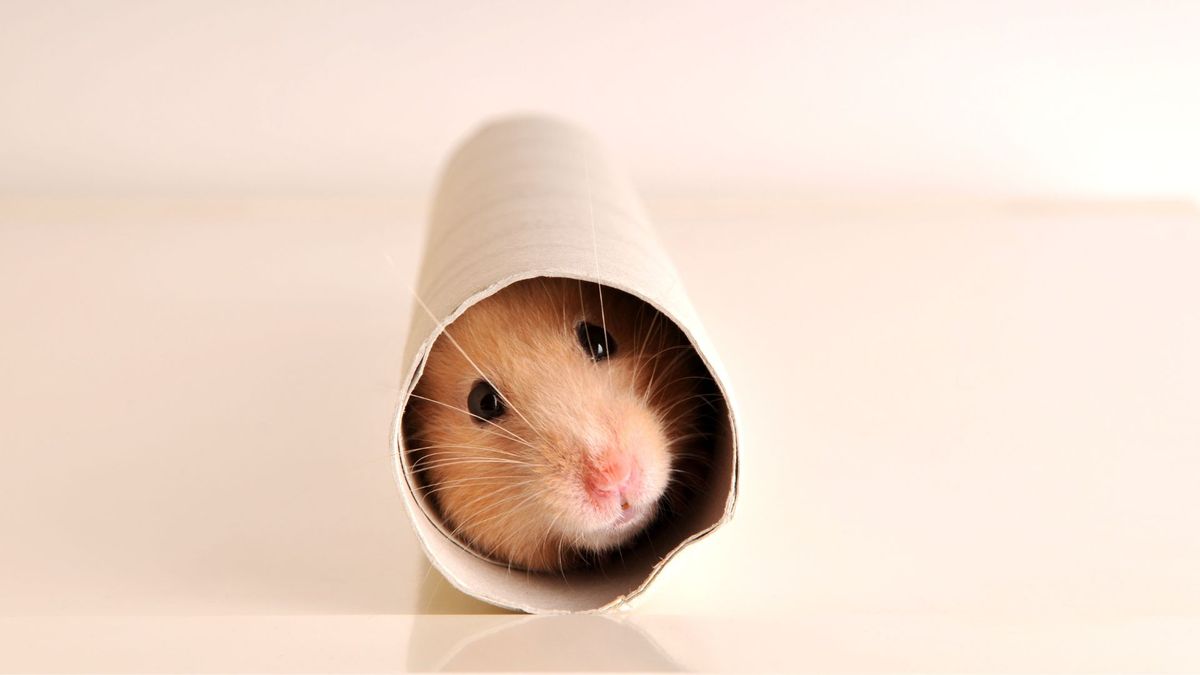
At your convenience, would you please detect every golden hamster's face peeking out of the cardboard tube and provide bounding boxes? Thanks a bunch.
[404,277,715,572]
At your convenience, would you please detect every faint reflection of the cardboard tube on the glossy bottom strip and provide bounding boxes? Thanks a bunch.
[404,614,680,673]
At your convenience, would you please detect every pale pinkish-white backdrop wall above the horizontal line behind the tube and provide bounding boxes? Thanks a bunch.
[0,0,1200,198]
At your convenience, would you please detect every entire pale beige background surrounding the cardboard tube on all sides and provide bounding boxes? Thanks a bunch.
[0,2,1200,671]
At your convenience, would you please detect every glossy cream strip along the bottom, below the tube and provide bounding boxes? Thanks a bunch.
[0,614,1200,673]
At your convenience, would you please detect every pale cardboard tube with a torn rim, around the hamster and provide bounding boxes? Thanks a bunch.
[392,118,737,613]
